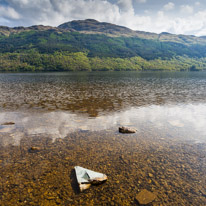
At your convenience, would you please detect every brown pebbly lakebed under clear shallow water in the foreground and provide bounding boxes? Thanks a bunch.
[0,131,206,205]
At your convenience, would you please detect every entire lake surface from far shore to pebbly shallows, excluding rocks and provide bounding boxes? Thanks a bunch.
[0,72,206,205]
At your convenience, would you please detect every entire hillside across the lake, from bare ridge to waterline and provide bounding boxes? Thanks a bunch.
[0,20,206,71]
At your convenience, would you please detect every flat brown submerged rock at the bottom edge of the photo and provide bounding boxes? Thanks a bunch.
[136,189,156,205]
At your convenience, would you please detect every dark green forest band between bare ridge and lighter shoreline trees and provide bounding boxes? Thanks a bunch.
[0,30,206,60]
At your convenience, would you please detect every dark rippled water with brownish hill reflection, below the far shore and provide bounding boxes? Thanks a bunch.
[0,72,206,117]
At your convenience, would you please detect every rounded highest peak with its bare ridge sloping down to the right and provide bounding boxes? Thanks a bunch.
[58,19,206,44]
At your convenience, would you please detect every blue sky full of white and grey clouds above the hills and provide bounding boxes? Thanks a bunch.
[0,0,206,36]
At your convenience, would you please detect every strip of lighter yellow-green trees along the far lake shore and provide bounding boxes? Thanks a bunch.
[0,52,206,72]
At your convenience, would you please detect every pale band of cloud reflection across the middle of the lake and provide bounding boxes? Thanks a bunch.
[0,104,206,146]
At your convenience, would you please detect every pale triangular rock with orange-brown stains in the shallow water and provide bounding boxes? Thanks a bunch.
[74,166,107,192]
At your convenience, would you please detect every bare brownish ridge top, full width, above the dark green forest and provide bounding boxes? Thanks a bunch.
[0,19,206,45]
